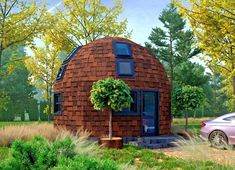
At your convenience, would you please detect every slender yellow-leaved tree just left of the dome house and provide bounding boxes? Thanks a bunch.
[25,44,62,121]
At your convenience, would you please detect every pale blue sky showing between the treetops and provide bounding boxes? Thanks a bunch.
[47,0,170,45]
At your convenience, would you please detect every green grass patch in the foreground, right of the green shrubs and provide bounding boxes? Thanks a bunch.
[100,145,232,170]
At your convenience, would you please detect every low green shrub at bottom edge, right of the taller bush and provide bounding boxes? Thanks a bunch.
[53,156,119,170]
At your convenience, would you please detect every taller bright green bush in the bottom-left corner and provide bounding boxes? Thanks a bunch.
[0,136,76,170]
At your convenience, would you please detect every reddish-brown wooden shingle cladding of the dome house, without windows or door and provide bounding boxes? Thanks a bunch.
[54,38,171,137]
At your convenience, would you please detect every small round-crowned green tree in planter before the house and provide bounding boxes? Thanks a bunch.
[90,78,132,139]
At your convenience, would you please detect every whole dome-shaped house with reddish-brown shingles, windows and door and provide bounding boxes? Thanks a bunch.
[54,37,171,137]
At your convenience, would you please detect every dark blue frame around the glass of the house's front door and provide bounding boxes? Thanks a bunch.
[139,89,160,136]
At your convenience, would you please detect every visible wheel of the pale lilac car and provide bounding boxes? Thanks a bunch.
[209,130,228,149]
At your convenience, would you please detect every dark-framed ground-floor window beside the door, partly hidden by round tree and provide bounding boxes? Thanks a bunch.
[114,91,139,116]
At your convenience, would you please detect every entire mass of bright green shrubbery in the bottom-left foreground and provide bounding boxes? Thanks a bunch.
[0,135,119,170]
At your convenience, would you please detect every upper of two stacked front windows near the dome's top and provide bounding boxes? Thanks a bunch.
[113,42,132,58]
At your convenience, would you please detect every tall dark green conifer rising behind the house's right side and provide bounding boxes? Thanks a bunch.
[145,4,200,115]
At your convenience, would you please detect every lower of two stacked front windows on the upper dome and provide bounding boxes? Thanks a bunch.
[116,60,134,77]
